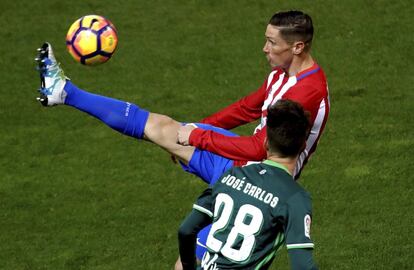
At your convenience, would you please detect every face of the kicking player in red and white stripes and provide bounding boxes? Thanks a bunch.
[263,24,293,69]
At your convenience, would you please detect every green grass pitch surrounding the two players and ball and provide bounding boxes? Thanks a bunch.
[0,0,414,270]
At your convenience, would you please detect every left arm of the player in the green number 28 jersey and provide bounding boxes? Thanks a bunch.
[178,188,213,270]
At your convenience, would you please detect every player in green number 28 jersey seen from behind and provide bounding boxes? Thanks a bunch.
[178,100,317,270]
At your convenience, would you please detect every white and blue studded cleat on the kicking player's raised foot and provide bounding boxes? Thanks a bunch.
[35,42,68,106]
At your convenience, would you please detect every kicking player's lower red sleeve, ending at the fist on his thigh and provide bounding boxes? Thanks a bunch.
[189,125,266,161]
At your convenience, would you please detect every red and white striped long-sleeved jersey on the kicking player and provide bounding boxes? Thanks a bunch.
[189,63,330,178]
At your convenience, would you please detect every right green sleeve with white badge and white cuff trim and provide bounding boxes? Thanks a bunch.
[285,192,314,250]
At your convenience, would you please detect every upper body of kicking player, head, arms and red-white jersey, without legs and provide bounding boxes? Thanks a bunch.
[178,11,330,178]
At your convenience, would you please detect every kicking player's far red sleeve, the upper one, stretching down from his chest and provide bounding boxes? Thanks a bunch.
[201,81,267,129]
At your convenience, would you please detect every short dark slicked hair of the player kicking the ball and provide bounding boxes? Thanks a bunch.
[269,10,313,51]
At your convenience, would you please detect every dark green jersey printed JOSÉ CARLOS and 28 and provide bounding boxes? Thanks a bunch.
[193,160,313,269]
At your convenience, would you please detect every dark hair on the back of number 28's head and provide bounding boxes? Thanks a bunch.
[267,99,310,157]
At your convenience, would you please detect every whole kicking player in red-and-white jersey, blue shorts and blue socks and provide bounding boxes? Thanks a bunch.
[37,11,329,266]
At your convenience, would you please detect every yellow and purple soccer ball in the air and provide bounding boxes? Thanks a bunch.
[66,15,118,65]
